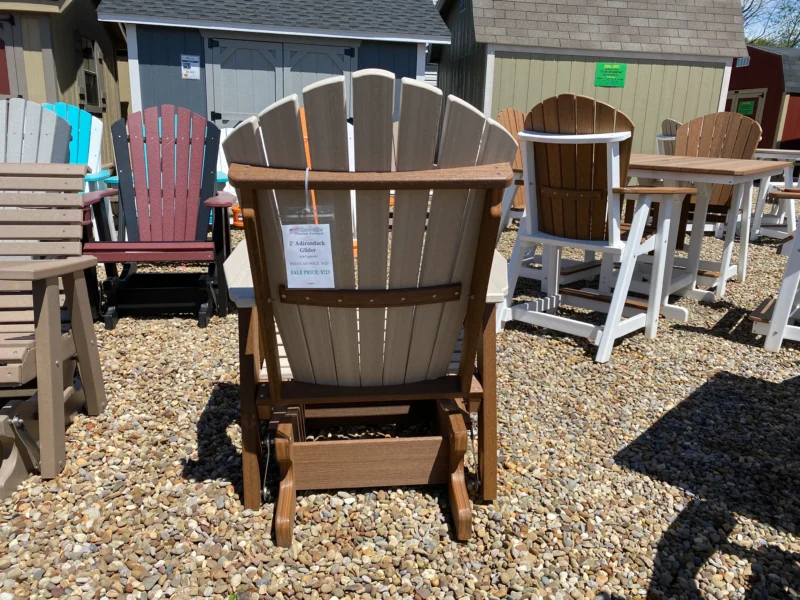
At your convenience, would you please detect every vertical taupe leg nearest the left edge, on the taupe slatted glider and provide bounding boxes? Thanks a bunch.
[33,273,65,479]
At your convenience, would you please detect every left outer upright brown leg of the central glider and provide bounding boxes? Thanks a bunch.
[239,308,263,510]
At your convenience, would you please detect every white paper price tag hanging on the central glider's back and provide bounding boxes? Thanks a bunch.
[281,223,335,288]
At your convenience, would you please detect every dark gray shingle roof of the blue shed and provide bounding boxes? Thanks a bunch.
[97,0,450,41]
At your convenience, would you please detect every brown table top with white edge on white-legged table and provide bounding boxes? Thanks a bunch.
[628,154,792,177]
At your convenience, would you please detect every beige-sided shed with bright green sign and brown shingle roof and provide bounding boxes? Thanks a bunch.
[437,0,747,152]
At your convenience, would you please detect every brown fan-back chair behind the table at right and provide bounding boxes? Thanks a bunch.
[675,112,761,251]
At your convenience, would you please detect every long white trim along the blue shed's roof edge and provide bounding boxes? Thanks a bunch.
[97,12,450,44]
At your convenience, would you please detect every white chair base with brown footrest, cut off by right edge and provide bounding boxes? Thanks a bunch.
[748,226,800,352]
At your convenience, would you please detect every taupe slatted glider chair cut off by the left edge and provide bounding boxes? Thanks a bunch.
[0,163,106,498]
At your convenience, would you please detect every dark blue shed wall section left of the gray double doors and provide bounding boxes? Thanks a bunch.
[136,25,208,117]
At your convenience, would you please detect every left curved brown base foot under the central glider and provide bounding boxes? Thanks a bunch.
[273,408,299,548]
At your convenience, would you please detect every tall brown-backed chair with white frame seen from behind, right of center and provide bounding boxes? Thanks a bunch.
[499,94,695,362]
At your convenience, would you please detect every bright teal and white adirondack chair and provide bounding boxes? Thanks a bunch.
[42,102,117,240]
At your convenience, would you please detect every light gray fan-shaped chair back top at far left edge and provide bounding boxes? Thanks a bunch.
[0,98,71,163]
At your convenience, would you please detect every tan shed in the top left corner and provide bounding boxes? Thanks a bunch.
[0,0,126,164]
